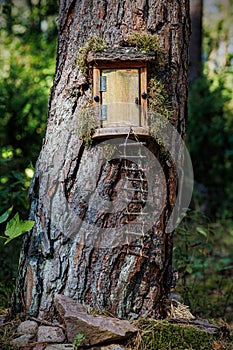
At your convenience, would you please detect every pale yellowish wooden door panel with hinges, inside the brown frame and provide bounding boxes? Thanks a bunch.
[100,68,141,127]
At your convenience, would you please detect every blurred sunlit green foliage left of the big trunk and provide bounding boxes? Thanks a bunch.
[0,0,58,308]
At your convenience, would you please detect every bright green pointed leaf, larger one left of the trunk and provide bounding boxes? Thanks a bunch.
[4,213,34,244]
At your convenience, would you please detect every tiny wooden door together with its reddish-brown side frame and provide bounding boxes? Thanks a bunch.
[93,62,147,134]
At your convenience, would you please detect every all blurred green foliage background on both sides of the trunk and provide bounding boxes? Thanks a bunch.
[0,0,233,328]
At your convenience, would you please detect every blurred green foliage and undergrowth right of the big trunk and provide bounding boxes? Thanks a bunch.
[174,0,233,324]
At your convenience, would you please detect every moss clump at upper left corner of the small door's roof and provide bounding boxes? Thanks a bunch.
[76,36,107,76]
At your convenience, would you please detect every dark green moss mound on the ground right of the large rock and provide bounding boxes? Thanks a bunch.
[131,319,232,350]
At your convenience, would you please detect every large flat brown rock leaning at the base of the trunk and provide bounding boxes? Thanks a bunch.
[55,294,138,345]
